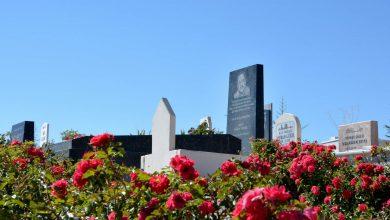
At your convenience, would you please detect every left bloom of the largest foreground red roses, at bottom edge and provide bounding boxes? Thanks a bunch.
[232,188,271,219]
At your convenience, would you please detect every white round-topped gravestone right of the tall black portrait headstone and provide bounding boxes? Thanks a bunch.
[274,113,302,145]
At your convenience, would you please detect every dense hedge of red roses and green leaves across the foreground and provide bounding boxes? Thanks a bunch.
[0,134,390,220]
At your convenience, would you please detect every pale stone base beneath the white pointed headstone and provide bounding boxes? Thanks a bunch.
[141,149,246,176]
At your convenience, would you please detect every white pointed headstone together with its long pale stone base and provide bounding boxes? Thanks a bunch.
[141,98,242,176]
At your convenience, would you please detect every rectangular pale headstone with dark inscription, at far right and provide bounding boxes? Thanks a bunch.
[339,121,379,152]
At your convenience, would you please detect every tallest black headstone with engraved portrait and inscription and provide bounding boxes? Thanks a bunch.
[226,64,264,155]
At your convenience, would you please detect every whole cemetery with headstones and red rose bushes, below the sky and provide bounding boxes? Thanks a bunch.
[0,64,390,220]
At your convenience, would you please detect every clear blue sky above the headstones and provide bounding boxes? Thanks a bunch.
[0,0,390,141]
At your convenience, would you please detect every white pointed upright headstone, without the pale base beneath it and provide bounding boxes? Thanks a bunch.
[152,98,176,154]
